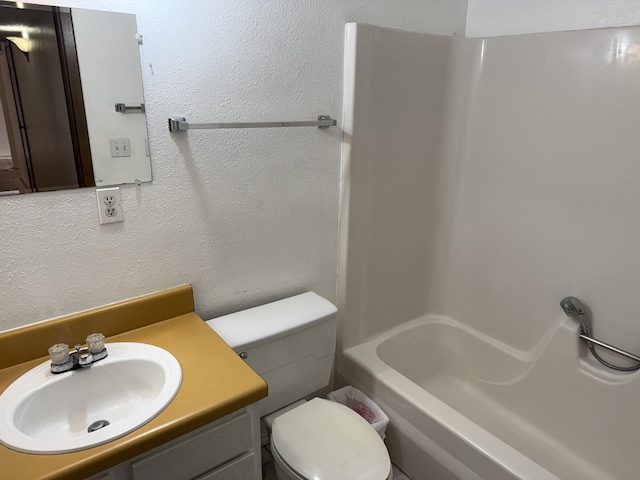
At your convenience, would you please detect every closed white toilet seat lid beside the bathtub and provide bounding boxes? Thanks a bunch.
[271,398,391,480]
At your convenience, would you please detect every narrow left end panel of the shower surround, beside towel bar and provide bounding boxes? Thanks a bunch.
[339,24,450,345]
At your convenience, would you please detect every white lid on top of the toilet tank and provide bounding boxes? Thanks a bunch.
[206,292,338,349]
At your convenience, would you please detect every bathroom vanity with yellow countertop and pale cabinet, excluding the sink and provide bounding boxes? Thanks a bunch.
[0,285,267,480]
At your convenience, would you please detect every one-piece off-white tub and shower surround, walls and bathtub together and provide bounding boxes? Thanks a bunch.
[338,24,640,480]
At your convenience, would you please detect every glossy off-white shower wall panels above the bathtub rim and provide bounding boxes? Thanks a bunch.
[341,25,640,351]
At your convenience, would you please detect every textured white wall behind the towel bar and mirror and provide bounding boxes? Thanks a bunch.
[0,0,466,330]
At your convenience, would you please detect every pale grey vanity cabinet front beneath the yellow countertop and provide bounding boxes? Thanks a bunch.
[88,404,262,480]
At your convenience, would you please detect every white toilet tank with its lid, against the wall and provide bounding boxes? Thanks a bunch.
[206,292,337,416]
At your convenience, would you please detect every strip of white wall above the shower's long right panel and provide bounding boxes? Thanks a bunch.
[466,0,640,37]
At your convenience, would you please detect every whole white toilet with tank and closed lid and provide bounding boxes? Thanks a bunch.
[207,292,392,480]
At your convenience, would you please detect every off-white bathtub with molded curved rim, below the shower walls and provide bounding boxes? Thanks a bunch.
[338,316,640,480]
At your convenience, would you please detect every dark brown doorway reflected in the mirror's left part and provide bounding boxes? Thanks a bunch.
[0,7,95,194]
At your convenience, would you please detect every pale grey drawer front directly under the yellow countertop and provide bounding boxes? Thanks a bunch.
[131,413,251,480]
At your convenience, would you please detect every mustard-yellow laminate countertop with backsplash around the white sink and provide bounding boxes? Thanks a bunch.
[0,285,267,480]
